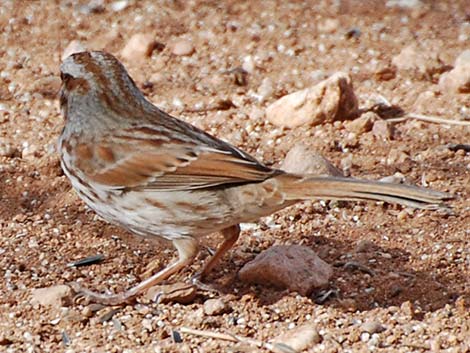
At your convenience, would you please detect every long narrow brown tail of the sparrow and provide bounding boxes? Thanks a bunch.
[278,174,452,209]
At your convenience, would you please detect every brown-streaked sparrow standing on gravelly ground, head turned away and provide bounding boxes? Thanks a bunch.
[58,51,451,305]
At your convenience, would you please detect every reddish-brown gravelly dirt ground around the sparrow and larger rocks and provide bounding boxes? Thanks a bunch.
[0,0,470,352]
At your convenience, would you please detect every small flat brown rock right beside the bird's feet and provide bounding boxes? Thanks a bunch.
[144,282,197,304]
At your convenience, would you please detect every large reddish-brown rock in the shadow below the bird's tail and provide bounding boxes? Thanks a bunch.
[239,245,333,295]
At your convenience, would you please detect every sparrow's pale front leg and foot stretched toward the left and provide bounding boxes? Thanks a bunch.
[70,237,199,305]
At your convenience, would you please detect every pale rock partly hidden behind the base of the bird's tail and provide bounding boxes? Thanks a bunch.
[281,143,343,176]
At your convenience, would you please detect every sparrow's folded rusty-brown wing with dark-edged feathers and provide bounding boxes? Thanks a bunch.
[77,129,280,190]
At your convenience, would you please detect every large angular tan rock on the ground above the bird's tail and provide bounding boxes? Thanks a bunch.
[266,72,358,128]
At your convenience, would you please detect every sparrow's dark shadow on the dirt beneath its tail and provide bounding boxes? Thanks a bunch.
[201,231,470,315]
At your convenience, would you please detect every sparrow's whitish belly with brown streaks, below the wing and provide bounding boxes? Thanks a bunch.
[67,173,233,240]
